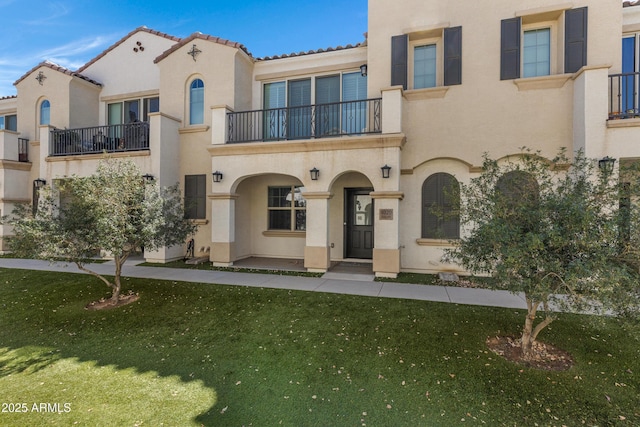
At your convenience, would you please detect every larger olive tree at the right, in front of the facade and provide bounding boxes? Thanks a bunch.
[444,149,639,359]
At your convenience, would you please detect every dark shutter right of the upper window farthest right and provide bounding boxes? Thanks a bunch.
[564,7,587,73]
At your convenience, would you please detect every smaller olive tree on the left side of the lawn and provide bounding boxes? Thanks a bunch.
[8,157,195,305]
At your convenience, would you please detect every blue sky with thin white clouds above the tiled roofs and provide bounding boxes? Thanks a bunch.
[0,0,367,97]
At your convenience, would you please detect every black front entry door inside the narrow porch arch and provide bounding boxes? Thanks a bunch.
[345,188,373,259]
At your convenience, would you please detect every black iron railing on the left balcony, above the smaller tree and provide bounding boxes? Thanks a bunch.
[49,122,149,156]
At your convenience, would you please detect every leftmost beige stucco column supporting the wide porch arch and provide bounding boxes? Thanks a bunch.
[209,193,238,267]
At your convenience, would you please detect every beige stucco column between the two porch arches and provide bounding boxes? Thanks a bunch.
[303,192,333,272]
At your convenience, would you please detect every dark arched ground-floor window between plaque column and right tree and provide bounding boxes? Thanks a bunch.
[422,173,460,239]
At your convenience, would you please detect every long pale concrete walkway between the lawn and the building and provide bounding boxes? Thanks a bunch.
[0,258,526,308]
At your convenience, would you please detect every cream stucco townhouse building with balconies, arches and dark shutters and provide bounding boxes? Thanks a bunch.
[0,0,640,276]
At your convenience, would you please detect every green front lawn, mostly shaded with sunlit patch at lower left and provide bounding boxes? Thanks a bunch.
[0,270,640,427]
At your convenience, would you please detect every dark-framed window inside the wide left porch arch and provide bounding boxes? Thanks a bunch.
[268,186,307,231]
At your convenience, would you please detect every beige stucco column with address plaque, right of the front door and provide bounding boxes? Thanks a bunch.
[371,191,404,277]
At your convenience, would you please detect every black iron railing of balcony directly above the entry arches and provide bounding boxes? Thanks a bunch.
[227,98,382,143]
